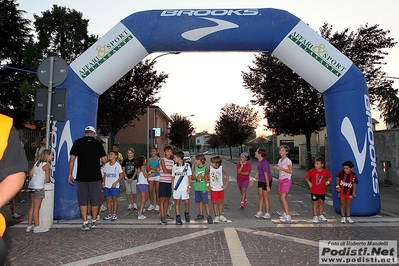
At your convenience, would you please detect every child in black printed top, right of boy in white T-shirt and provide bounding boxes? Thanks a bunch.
[122,148,137,211]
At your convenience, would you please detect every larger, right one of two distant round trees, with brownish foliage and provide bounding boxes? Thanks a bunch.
[215,103,261,158]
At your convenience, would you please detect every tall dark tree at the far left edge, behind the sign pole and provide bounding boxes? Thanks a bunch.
[0,0,35,128]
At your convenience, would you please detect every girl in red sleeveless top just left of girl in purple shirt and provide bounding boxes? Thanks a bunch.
[236,152,252,208]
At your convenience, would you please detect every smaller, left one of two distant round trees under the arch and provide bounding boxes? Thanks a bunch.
[169,113,194,149]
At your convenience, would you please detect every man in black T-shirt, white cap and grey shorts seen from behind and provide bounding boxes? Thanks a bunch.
[68,126,107,231]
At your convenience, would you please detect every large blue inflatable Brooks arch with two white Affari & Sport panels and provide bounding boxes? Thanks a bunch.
[51,8,381,219]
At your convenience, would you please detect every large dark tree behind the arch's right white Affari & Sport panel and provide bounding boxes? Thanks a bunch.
[243,23,396,167]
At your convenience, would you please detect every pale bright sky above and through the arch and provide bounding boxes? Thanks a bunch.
[17,0,399,134]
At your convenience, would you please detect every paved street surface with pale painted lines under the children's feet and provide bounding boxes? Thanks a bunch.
[1,157,399,266]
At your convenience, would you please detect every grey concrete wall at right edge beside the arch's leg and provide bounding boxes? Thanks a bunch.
[374,129,399,187]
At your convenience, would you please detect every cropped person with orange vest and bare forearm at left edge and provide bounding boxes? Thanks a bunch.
[0,114,28,265]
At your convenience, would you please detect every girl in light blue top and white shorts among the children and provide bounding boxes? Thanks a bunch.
[147,148,160,211]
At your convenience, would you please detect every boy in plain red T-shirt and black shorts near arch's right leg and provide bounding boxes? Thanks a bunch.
[305,157,332,223]
